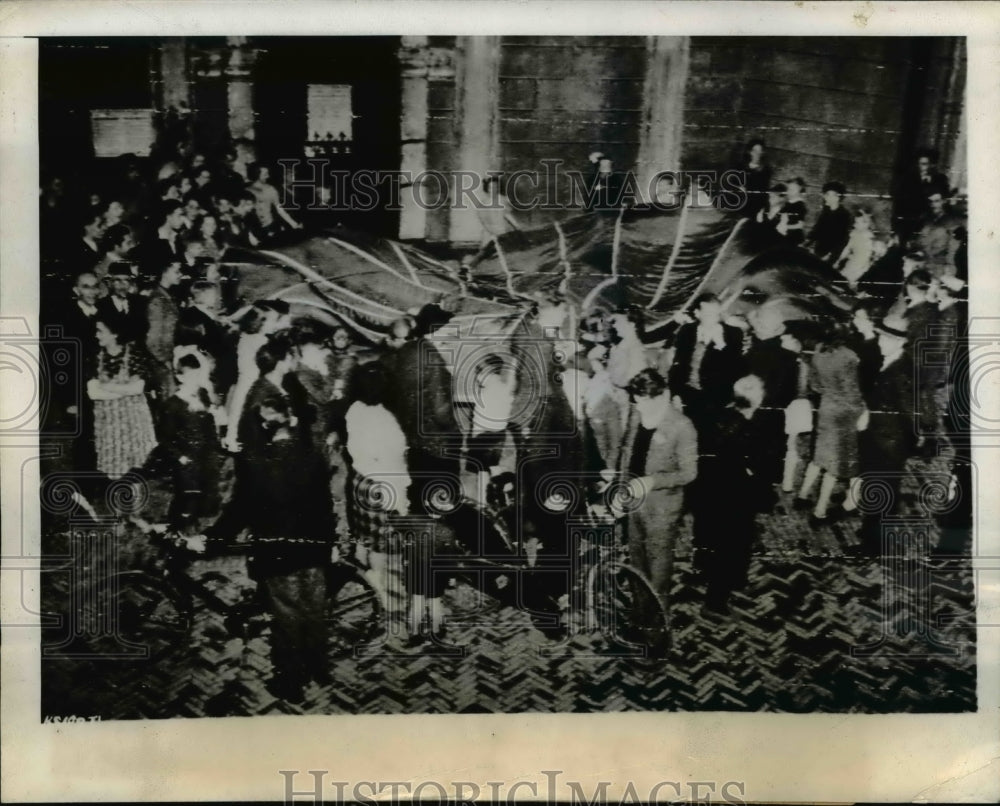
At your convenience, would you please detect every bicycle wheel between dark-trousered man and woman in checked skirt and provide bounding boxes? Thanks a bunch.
[326,562,382,655]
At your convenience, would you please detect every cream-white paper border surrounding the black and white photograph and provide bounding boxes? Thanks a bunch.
[0,0,1000,803]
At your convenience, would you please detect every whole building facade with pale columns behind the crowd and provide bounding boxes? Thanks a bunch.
[41,36,965,242]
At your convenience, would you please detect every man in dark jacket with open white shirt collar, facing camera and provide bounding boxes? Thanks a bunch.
[667,293,743,431]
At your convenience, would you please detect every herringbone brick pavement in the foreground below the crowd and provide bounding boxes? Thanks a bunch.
[41,454,976,719]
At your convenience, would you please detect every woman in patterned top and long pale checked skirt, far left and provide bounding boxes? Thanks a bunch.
[87,321,156,479]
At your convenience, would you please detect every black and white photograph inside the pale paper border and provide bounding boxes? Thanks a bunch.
[4,4,997,802]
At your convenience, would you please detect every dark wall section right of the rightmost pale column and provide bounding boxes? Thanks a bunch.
[683,37,964,213]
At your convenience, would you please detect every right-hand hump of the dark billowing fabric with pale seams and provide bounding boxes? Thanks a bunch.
[472,207,848,318]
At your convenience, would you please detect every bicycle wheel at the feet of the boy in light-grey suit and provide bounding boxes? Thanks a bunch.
[587,562,669,655]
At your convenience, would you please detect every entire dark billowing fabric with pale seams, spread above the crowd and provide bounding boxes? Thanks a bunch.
[223,207,849,342]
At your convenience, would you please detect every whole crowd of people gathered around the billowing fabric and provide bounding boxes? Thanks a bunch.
[41,136,967,698]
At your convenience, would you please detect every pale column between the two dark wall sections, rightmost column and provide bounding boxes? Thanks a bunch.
[636,36,691,202]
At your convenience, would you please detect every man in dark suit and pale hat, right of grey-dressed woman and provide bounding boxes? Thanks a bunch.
[858,318,915,555]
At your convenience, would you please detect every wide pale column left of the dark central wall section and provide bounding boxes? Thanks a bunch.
[448,36,500,244]
